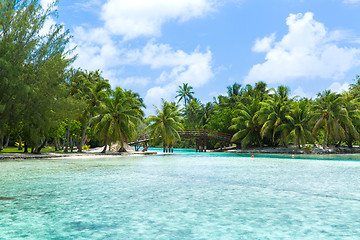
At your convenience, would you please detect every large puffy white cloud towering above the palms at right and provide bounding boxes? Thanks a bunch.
[245,12,360,83]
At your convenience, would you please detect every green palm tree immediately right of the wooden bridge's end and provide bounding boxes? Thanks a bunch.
[230,101,262,148]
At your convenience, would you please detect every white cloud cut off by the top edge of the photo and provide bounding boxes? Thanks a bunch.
[101,0,213,39]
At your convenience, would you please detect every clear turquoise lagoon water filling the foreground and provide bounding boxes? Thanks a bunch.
[0,151,360,239]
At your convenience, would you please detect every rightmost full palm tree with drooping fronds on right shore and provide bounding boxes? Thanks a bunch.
[312,90,355,148]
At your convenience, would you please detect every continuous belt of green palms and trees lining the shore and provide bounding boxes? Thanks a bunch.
[0,0,360,153]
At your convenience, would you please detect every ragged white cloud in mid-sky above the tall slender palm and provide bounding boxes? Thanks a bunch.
[136,42,214,112]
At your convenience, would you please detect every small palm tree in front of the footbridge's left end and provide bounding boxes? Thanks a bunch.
[147,100,183,152]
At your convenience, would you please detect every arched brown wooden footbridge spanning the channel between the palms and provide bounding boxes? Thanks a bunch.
[129,129,232,152]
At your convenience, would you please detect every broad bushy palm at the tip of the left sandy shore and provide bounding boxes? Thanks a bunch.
[91,87,144,153]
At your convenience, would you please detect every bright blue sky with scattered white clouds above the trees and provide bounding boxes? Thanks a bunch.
[41,0,360,114]
